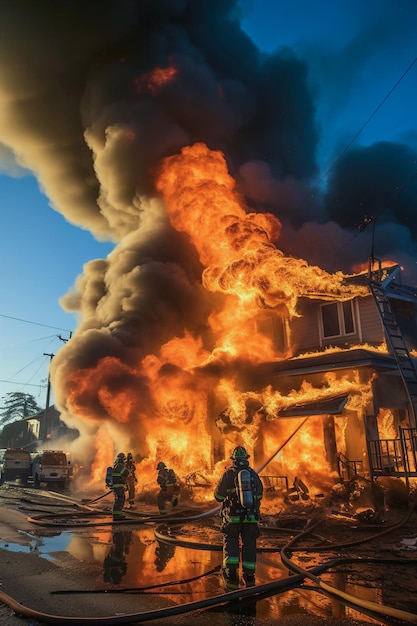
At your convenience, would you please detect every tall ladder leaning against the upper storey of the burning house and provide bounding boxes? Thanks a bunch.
[369,276,417,425]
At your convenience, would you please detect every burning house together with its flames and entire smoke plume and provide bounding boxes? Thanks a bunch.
[0,0,416,492]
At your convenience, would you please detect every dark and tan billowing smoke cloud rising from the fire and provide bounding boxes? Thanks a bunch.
[0,0,417,468]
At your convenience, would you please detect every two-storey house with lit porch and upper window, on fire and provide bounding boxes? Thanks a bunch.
[234,258,417,482]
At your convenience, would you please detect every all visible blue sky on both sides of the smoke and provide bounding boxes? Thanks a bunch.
[0,0,417,408]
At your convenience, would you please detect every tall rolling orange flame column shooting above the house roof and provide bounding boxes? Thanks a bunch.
[157,143,367,308]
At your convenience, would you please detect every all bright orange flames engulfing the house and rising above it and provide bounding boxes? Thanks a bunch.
[68,141,384,492]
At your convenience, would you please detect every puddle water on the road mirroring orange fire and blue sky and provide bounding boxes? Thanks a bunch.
[0,527,381,624]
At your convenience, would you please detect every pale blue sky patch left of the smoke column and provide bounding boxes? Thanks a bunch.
[0,175,113,408]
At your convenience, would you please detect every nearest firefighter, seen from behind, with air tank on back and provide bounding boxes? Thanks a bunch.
[214,446,263,590]
